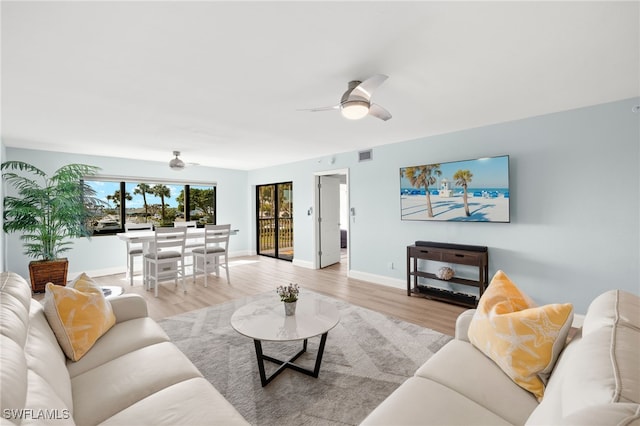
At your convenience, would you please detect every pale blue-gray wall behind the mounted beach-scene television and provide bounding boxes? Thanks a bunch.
[249,98,640,313]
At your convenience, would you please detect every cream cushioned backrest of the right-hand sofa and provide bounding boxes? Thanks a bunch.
[527,290,640,425]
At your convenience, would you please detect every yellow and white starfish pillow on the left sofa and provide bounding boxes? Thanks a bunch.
[44,274,116,361]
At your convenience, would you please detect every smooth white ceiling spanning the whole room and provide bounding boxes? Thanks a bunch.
[1,1,640,170]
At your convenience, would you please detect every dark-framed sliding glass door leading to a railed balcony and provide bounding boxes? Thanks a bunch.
[256,182,293,260]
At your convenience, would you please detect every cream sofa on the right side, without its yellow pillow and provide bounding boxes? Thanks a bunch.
[362,290,640,426]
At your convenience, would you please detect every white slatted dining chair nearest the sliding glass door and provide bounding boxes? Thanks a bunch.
[191,224,231,287]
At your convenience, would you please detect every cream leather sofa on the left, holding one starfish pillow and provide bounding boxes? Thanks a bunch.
[0,272,248,426]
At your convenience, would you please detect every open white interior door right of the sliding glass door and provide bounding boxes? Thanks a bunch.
[318,176,340,268]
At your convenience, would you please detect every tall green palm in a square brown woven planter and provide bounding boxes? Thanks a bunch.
[0,161,103,292]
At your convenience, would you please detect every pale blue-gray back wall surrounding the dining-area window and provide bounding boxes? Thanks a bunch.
[4,148,250,278]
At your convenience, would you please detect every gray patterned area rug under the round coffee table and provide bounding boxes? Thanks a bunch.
[160,290,451,425]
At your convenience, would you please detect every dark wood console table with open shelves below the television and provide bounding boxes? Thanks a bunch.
[407,241,489,308]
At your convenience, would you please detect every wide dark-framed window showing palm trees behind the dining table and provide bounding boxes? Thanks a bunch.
[85,177,216,235]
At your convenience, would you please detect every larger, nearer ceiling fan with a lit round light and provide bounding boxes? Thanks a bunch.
[303,74,391,121]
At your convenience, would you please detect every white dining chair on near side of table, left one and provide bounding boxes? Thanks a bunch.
[144,227,187,297]
